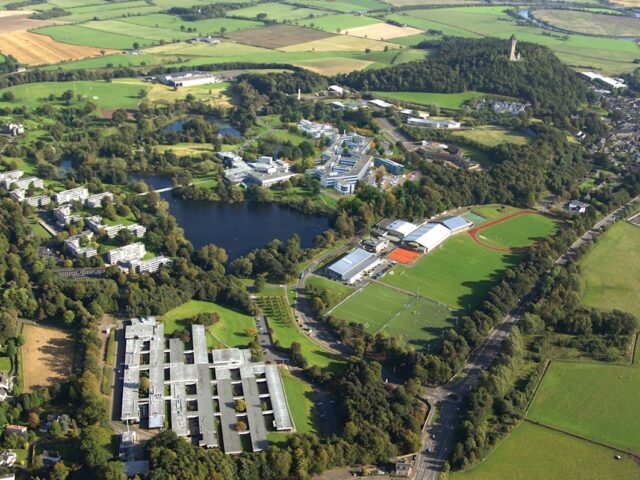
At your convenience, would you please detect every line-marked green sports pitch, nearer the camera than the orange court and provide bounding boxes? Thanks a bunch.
[331,283,452,346]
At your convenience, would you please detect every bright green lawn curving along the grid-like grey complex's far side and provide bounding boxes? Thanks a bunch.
[161,300,255,348]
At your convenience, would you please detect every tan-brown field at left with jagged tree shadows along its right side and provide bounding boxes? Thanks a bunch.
[20,325,75,392]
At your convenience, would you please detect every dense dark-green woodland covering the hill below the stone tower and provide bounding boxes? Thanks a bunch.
[337,38,586,117]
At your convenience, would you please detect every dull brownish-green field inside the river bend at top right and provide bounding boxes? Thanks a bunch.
[532,9,640,37]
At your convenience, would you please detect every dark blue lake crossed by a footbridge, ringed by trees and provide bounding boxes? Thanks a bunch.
[132,175,329,260]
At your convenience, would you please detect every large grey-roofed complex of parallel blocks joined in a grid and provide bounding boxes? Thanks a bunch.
[121,318,293,454]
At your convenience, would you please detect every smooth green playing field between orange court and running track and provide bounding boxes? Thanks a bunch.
[382,233,521,312]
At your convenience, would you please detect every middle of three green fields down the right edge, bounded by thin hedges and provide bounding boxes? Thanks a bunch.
[528,361,640,452]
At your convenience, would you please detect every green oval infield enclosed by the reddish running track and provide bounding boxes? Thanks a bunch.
[479,214,558,248]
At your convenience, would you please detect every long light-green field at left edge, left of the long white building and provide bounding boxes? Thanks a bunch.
[3,81,150,109]
